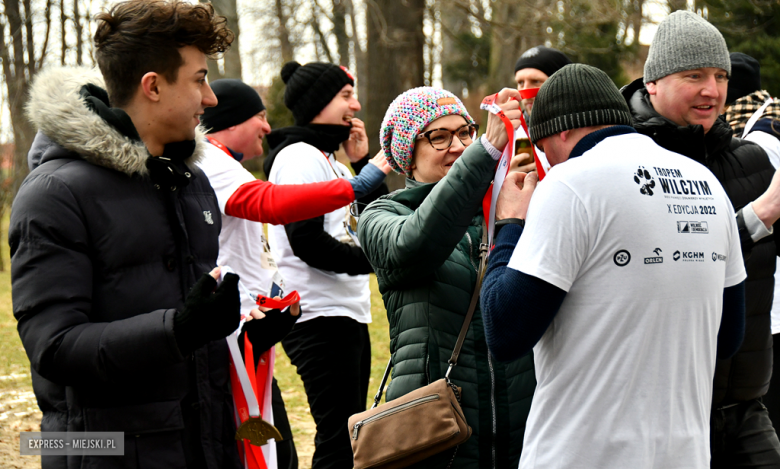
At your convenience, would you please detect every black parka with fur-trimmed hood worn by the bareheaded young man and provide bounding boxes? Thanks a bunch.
[9,69,241,469]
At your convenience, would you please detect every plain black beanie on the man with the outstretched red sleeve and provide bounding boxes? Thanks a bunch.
[200,78,265,133]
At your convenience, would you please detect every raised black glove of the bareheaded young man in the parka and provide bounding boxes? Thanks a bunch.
[173,273,241,355]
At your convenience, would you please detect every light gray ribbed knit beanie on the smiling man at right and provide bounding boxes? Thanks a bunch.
[644,11,731,84]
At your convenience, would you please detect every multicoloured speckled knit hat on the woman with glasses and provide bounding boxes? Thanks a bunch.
[379,86,474,177]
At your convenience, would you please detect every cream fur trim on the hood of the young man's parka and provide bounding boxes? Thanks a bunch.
[27,67,206,176]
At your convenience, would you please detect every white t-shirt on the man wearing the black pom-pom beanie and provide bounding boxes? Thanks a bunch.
[268,142,371,324]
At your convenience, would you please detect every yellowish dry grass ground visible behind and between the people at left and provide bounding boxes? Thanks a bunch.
[0,212,389,469]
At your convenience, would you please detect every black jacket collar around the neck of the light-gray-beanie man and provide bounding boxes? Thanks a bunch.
[621,78,732,163]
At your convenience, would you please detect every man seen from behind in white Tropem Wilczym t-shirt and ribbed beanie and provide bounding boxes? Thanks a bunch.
[482,64,745,469]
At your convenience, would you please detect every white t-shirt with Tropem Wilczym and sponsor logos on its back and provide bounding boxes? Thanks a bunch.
[509,133,746,469]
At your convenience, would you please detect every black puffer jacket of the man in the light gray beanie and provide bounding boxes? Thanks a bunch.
[621,78,780,407]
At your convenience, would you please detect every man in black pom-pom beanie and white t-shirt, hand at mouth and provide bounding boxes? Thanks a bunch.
[264,62,380,469]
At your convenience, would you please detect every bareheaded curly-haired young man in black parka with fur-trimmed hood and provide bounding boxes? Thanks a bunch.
[9,0,242,469]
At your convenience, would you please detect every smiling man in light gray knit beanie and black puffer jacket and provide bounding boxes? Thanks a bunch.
[622,11,780,468]
